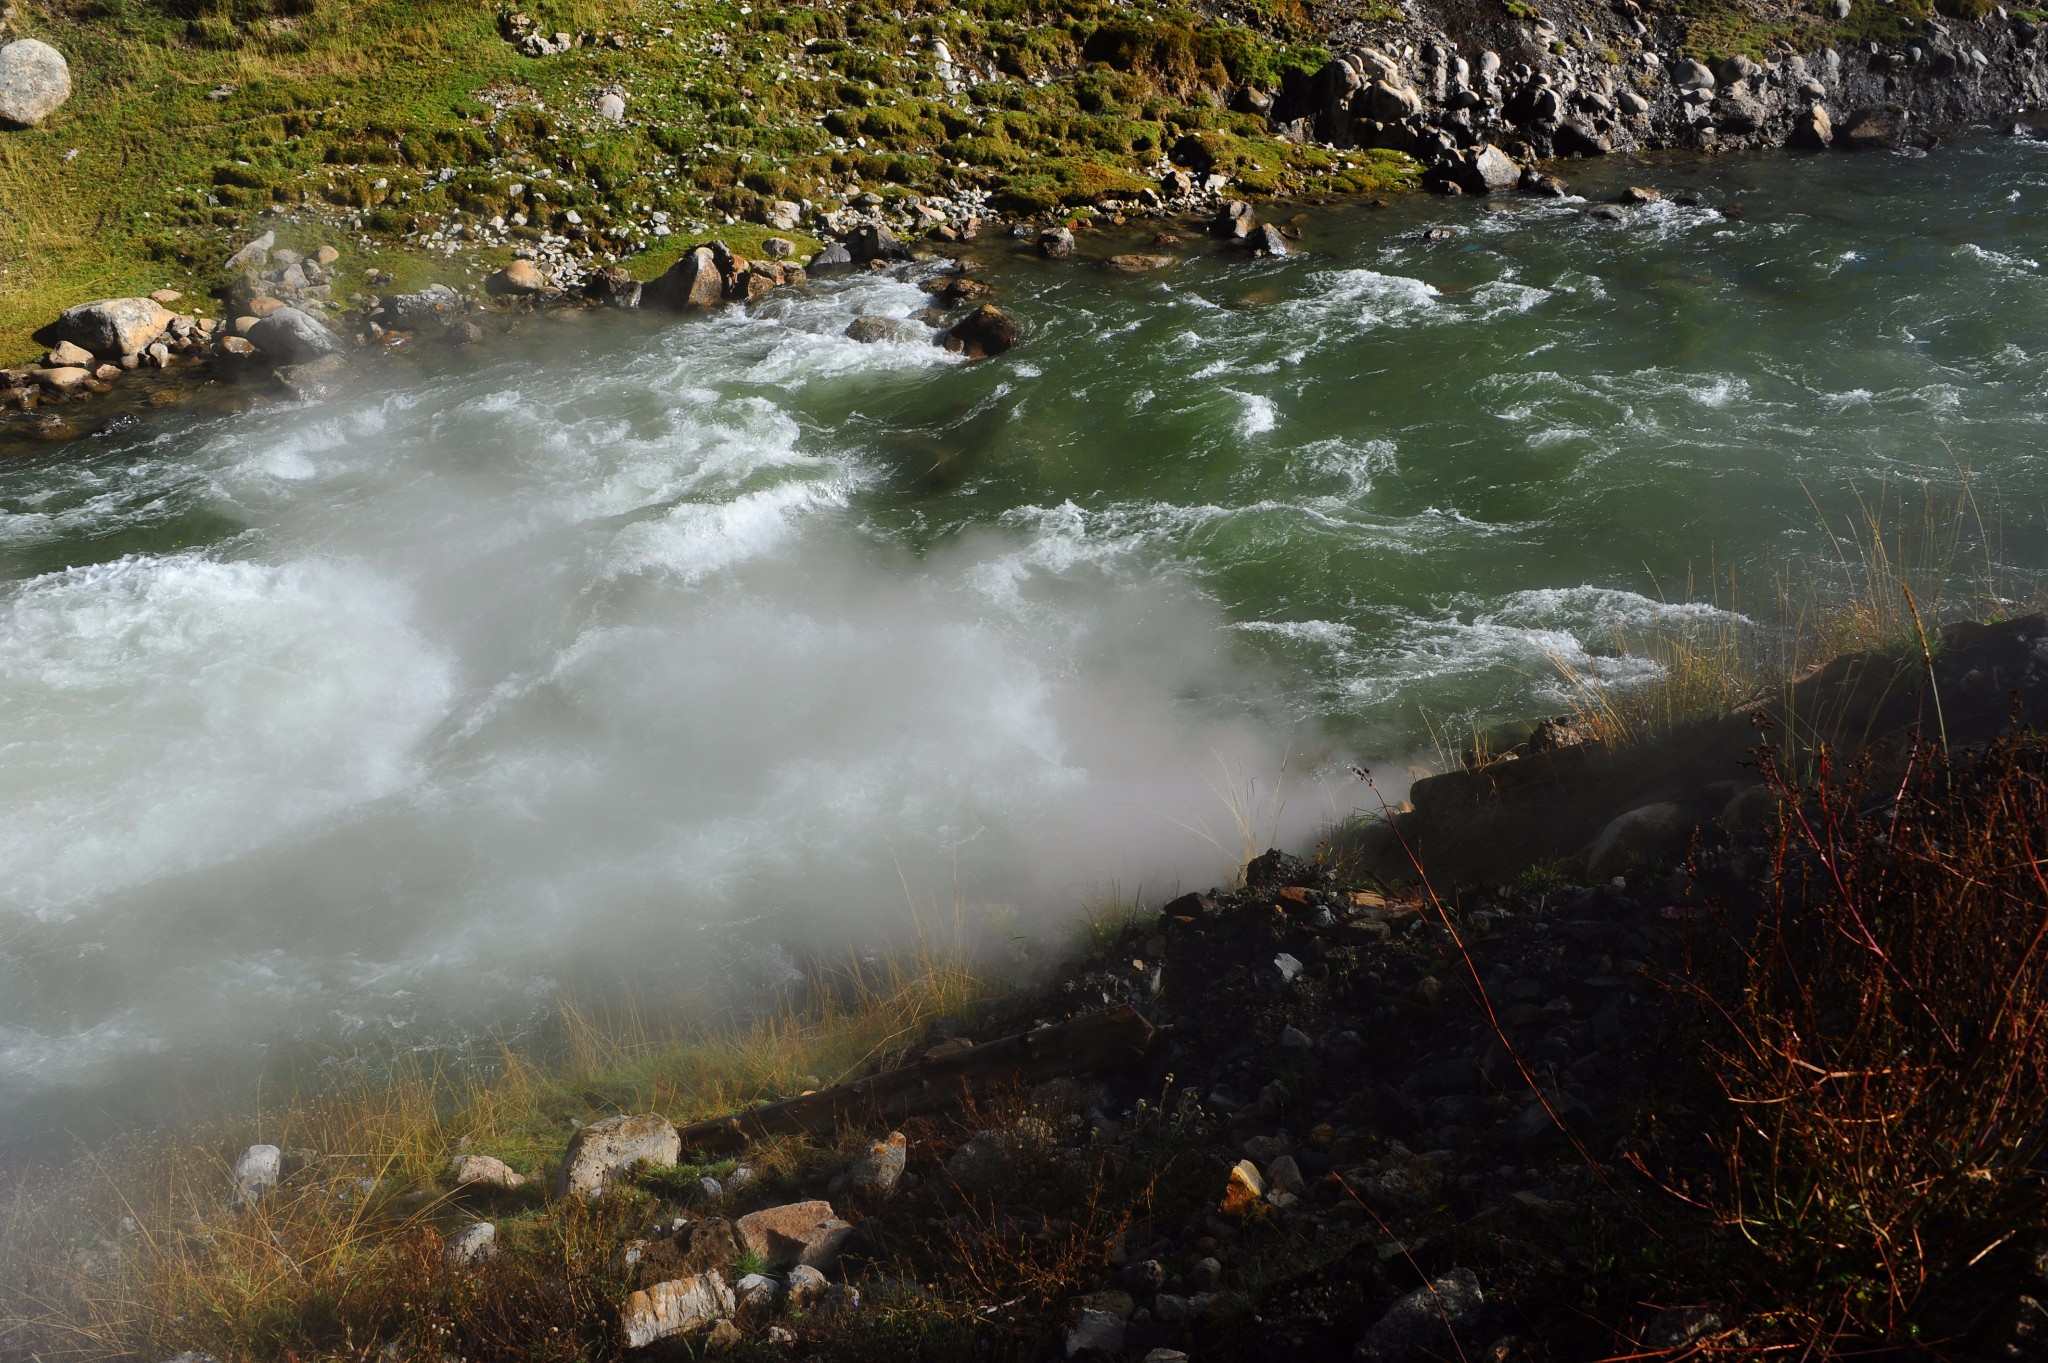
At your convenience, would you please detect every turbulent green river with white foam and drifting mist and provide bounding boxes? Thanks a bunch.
[0,141,2048,1140]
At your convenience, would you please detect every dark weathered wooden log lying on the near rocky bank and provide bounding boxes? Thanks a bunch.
[680,1007,1153,1150]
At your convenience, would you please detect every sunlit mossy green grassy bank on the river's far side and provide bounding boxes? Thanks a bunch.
[0,0,1413,362]
